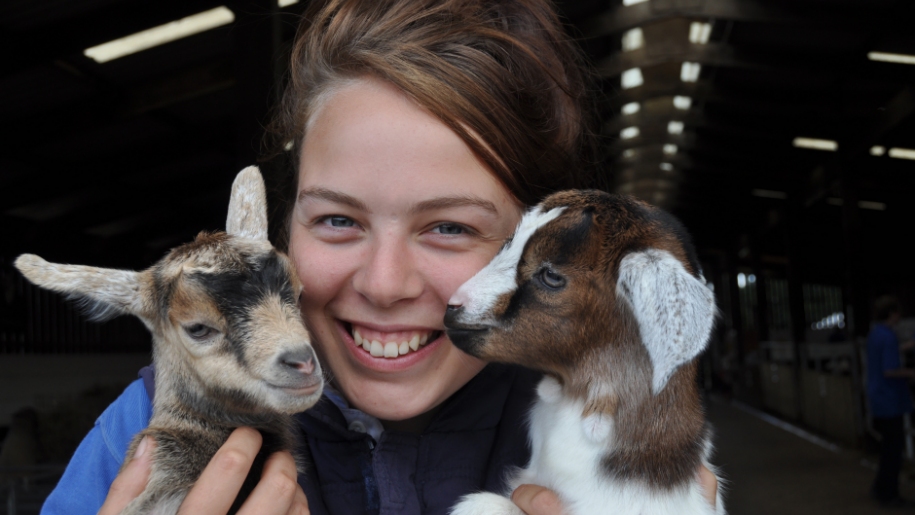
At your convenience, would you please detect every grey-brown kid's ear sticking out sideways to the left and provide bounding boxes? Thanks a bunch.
[15,254,147,322]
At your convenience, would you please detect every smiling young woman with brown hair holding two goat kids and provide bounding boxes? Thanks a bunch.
[45,0,714,515]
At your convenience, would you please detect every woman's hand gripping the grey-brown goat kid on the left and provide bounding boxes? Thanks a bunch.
[99,427,310,515]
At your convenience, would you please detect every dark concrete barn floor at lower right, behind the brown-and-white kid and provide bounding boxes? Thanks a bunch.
[708,398,915,515]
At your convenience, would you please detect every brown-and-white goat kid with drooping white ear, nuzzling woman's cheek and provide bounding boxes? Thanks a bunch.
[445,191,724,515]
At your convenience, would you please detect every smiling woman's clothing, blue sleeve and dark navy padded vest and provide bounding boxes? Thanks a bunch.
[41,365,540,515]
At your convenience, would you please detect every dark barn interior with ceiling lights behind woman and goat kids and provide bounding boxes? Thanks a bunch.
[0,0,915,514]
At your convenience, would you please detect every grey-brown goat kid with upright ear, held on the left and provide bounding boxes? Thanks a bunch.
[16,167,324,514]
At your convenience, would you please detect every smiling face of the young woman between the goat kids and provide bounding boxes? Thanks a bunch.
[289,79,521,421]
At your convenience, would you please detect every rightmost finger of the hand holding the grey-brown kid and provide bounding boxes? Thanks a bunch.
[238,452,310,515]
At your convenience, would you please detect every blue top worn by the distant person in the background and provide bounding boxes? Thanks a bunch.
[867,324,912,418]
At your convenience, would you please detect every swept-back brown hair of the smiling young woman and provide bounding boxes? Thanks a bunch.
[271,0,596,246]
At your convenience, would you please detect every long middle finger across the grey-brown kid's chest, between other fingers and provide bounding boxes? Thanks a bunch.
[178,427,263,515]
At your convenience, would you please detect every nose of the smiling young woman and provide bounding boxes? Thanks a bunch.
[354,235,424,307]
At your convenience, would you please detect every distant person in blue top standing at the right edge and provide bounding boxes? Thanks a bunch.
[867,296,915,507]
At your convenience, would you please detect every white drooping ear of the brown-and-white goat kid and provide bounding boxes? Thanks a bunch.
[617,249,717,394]
